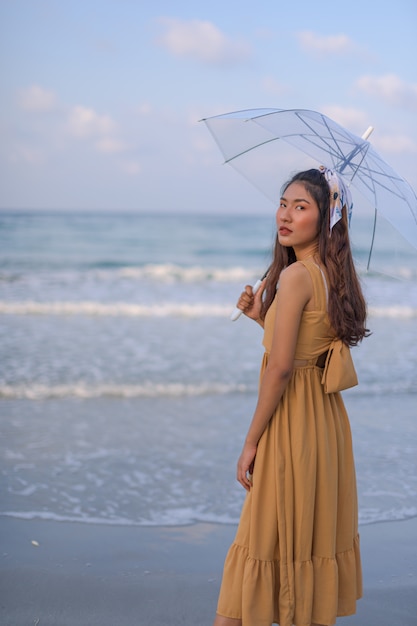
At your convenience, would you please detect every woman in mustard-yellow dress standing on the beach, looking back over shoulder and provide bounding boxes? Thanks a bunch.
[214,168,368,626]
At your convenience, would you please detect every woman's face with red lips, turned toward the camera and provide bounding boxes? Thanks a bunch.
[276,182,320,253]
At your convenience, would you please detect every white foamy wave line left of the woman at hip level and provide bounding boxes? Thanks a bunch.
[0,383,249,400]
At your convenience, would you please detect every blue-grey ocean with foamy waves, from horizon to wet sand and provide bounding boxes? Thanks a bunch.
[0,211,417,525]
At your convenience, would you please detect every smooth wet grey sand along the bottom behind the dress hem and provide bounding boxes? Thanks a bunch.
[0,517,417,626]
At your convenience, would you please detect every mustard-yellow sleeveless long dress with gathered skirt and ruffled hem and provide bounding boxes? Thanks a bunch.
[217,259,362,626]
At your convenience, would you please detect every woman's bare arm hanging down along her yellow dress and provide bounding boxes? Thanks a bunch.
[237,263,313,490]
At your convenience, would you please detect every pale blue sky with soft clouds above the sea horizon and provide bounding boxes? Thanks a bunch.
[0,0,417,213]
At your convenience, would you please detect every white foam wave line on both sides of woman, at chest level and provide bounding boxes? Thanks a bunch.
[0,300,417,319]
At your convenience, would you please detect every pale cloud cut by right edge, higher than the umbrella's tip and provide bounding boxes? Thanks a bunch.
[356,74,417,111]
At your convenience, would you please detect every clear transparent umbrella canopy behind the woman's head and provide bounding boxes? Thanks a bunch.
[202,109,417,276]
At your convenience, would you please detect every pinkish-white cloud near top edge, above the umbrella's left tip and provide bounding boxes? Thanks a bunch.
[158,17,250,64]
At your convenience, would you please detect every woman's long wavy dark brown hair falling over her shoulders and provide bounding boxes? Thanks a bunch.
[261,169,369,346]
